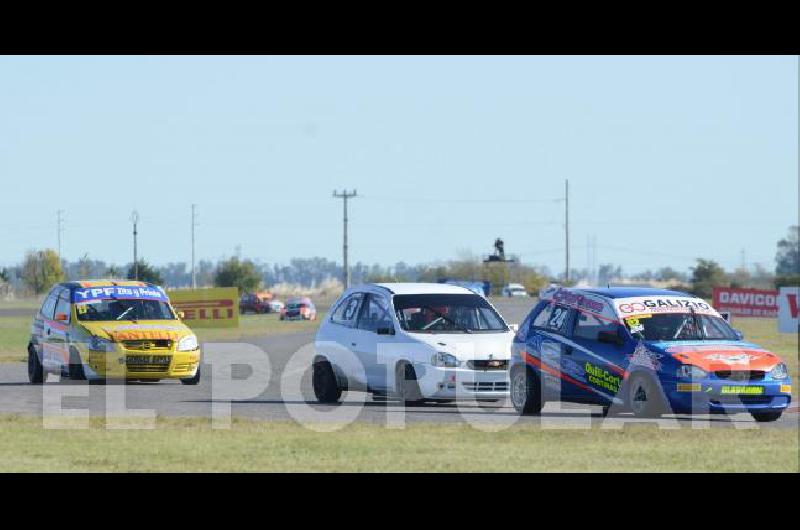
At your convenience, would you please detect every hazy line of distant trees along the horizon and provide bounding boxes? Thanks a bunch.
[0,226,800,298]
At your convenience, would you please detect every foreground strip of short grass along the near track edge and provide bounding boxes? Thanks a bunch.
[0,416,798,473]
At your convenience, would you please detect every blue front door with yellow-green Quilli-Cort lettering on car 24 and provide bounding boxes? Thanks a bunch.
[572,311,626,404]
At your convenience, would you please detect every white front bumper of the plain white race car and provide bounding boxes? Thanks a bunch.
[414,364,509,400]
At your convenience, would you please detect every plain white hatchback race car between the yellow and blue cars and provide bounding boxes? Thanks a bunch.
[313,283,516,404]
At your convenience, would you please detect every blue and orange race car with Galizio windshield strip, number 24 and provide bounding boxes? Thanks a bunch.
[510,287,792,422]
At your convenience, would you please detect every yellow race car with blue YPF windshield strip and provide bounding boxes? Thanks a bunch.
[28,280,200,385]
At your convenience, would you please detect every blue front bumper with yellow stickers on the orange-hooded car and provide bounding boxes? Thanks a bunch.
[665,378,792,414]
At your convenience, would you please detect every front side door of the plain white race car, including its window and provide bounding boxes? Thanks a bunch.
[353,293,395,391]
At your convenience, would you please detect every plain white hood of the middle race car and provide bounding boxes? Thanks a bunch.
[408,331,514,361]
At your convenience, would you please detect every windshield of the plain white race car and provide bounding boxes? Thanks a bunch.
[393,294,508,333]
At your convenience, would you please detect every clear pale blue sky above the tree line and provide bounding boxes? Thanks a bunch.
[0,57,798,272]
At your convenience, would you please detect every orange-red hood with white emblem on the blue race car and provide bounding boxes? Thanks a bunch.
[648,341,783,372]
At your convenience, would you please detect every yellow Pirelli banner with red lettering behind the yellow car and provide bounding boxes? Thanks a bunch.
[167,287,239,328]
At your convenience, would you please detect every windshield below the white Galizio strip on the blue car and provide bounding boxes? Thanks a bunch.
[624,313,739,341]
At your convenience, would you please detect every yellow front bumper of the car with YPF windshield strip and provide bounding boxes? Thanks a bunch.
[81,346,201,379]
